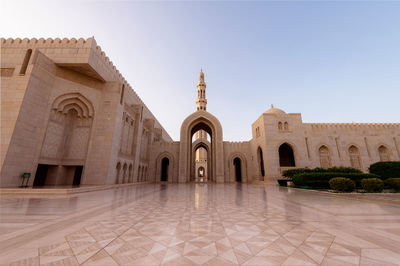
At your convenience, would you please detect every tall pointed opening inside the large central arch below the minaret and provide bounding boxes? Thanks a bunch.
[190,122,213,182]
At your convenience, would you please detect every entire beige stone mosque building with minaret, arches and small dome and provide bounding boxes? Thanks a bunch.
[0,38,400,187]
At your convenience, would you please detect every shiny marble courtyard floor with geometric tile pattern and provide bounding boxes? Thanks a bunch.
[0,184,400,265]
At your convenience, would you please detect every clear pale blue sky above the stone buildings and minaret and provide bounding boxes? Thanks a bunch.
[0,0,400,141]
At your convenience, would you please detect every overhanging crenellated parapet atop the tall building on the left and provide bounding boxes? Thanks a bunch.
[0,37,173,141]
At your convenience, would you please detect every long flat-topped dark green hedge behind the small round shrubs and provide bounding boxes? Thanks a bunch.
[292,173,379,188]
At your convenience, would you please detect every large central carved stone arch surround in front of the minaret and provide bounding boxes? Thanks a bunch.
[179,111,224,182]
